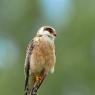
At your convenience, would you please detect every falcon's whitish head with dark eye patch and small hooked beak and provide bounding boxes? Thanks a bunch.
[37,26,56,39]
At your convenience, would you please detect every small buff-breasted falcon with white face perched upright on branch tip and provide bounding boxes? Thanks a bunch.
[24,26,56,95]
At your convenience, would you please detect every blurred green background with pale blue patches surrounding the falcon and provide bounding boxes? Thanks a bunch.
[0,0,95,95]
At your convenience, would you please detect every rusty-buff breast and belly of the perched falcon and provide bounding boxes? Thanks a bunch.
[30,37,55,72]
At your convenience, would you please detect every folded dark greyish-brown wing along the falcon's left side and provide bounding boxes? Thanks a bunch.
[24,40,34,95]
